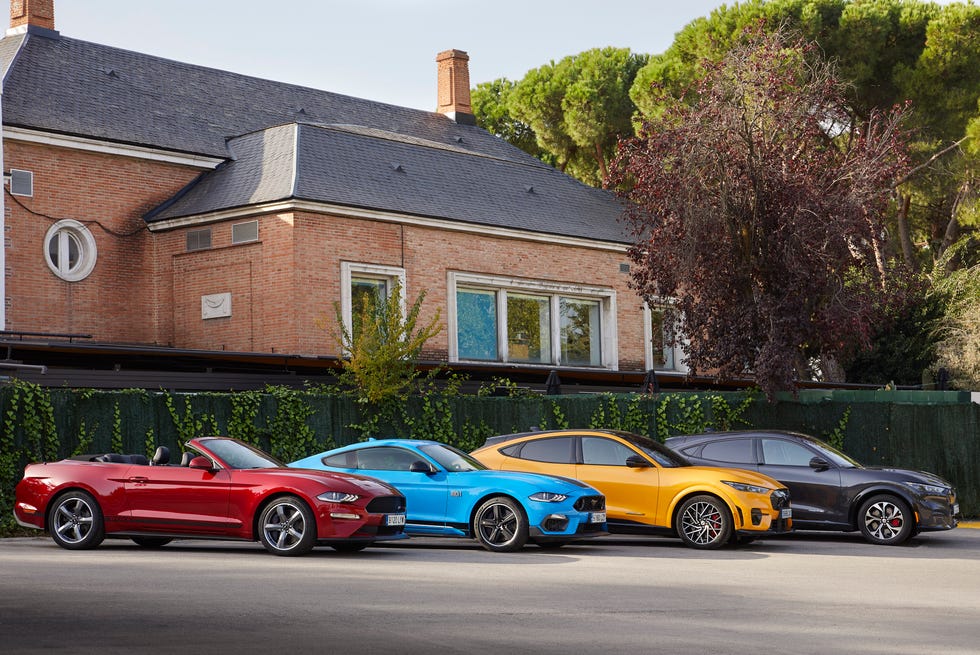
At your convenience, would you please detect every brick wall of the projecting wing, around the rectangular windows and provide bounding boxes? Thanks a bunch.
[159,212,645,370]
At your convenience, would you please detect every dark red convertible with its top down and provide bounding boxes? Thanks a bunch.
[14,437,406,555]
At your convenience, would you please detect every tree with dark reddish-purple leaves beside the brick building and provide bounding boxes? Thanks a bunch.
[609,31,907,397]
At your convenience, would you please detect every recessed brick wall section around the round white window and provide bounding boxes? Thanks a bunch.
[4,139,199,343]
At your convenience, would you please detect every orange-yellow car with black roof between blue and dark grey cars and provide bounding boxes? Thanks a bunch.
[471,430,792,548]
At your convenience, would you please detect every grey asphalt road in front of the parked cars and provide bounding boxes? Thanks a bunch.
[0,528,980,655]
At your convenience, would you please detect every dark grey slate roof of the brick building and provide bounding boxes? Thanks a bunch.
[0,28,627,243]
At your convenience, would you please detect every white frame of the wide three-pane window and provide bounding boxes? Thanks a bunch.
[446,271,619,371]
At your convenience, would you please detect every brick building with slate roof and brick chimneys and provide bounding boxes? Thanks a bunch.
[0,0,682,390]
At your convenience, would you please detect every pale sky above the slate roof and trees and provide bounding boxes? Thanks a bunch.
[13,0,736,111]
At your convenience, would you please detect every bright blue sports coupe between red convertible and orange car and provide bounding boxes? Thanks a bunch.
[289,439,606,551]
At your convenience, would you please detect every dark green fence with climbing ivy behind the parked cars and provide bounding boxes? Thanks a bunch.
[0,384,980,525]
